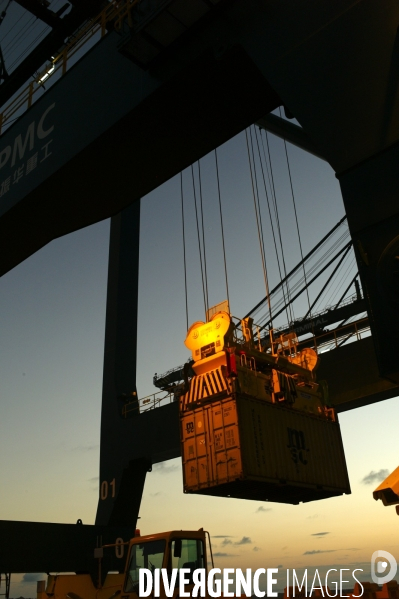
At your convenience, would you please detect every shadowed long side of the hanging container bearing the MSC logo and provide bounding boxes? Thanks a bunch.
[237,398,349,489]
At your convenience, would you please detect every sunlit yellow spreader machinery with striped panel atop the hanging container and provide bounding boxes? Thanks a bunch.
[181,311,335,419]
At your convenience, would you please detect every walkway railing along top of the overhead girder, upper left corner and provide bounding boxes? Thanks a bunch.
[0,0,141,135]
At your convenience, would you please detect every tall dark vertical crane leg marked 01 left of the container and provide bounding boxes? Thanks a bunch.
[96,201,151,527]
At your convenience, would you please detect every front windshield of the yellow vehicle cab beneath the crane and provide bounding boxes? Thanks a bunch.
[125,539,166,594]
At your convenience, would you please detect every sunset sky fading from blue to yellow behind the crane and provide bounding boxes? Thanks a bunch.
[0,119,399,597]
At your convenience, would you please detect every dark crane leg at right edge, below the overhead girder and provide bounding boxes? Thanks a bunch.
[338,143,399,383]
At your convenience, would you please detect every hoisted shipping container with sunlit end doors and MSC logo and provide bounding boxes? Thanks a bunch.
[180,394,350,504]
